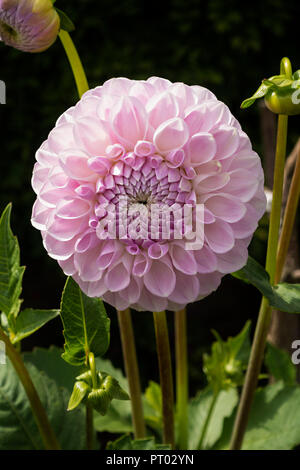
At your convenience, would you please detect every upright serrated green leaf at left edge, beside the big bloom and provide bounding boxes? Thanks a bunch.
[0,204,25,324]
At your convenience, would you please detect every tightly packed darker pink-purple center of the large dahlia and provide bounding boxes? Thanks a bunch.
[92,153,196,245]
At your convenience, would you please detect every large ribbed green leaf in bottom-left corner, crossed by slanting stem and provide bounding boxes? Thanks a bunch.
[0,360,85,450]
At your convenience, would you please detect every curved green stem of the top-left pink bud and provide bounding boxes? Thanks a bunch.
[59,29,89,98]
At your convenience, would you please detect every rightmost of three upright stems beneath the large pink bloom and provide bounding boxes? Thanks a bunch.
[175,310,188,450]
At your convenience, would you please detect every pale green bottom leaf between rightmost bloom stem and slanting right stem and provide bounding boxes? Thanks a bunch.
[188,388,238,449]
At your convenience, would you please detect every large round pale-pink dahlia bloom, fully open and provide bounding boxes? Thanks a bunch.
[32,77,266,311]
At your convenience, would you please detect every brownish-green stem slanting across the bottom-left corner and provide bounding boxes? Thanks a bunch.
[0,328,60,450]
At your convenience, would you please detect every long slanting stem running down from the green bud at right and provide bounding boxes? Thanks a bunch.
[230,114,288,450]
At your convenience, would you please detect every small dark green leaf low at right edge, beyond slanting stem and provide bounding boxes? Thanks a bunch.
[265,343,297,385]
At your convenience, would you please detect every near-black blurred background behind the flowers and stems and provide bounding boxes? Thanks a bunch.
[0,0,300,392]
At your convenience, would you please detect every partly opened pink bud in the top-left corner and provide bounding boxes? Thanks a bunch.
[0,0,60,52]
